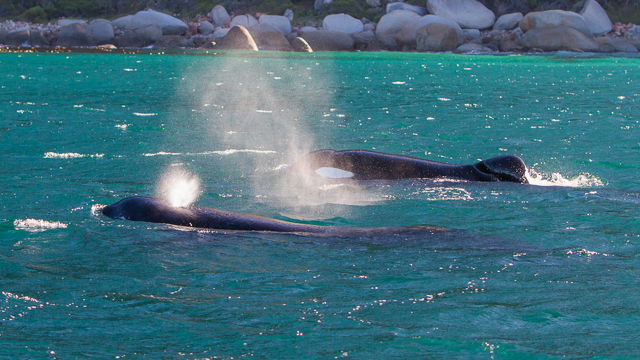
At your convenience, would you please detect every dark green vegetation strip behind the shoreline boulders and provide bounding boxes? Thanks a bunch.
[0,0,640,24]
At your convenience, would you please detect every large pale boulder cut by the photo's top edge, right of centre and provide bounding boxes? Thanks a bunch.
[427,0,496,29]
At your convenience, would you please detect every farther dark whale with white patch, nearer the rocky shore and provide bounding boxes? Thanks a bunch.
[290,149,528,184]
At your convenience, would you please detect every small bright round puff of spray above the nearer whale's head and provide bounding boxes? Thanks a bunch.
[156,166,202,207]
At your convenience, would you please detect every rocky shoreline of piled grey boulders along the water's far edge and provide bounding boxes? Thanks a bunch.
[0,0,640,54]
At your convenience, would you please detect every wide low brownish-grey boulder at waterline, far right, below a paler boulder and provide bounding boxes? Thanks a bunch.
[516,25,600,52]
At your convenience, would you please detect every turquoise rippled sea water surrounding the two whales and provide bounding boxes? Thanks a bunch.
[0,53,640,359]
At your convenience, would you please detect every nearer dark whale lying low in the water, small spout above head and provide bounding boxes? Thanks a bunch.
[102,196,448,235]
